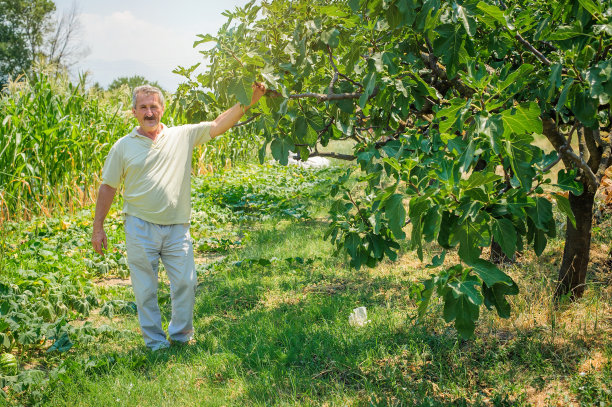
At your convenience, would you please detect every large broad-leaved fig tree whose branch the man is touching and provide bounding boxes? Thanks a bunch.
[175,0,612,336]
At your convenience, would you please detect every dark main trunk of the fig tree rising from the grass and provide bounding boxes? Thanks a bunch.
[555,189,595,300]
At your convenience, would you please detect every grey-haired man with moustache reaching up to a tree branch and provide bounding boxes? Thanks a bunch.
[91,83,265,350]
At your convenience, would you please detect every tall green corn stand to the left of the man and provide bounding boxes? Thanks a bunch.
[0,72,129,221]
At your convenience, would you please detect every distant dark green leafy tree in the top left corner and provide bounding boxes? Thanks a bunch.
[0,0,55,85]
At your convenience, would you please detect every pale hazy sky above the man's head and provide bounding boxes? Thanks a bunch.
[54,0,248,92]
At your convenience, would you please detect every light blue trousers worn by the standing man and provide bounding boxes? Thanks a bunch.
[125,215,197,350]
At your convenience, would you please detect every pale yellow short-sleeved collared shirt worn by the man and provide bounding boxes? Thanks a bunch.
[102,122,211,225]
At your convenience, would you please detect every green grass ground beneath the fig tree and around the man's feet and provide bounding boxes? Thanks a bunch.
[0,167,612,407]
